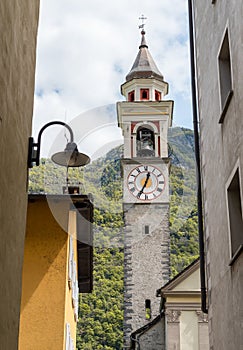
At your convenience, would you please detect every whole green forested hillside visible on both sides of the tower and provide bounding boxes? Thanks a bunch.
[29,128,198,350]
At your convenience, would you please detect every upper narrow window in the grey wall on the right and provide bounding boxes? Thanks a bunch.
[218,30,233,123]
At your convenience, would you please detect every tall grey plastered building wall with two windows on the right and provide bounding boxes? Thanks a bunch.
[193,0,243,350]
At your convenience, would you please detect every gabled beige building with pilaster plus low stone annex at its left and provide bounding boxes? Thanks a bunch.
[135,260,209,350]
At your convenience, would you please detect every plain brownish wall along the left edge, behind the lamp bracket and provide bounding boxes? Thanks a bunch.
[0,0,39,350]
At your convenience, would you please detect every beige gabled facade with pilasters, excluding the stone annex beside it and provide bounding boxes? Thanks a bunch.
[161,261,209,350]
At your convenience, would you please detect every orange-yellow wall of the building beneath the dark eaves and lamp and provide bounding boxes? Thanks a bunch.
[19,198,76,350]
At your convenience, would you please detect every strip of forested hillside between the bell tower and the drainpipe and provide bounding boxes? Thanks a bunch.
[169,127,198,277]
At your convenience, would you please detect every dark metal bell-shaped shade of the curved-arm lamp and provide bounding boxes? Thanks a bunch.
[51,142,90,167]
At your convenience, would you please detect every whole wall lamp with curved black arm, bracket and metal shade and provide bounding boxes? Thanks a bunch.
[28,121,90,168]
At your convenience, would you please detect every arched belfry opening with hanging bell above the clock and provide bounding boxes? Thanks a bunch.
[136,126,155,157]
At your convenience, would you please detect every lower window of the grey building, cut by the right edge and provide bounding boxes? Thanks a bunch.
[227,169,243,260]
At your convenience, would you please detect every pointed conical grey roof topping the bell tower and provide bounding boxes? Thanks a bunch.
[126,30,164,81]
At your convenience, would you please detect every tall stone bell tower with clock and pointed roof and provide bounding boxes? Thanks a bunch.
[117,25,173,349]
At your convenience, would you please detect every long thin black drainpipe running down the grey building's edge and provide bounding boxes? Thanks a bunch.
[188,0,208,313]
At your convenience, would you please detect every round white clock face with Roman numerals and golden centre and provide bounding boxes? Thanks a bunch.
[127,165,165,201]
